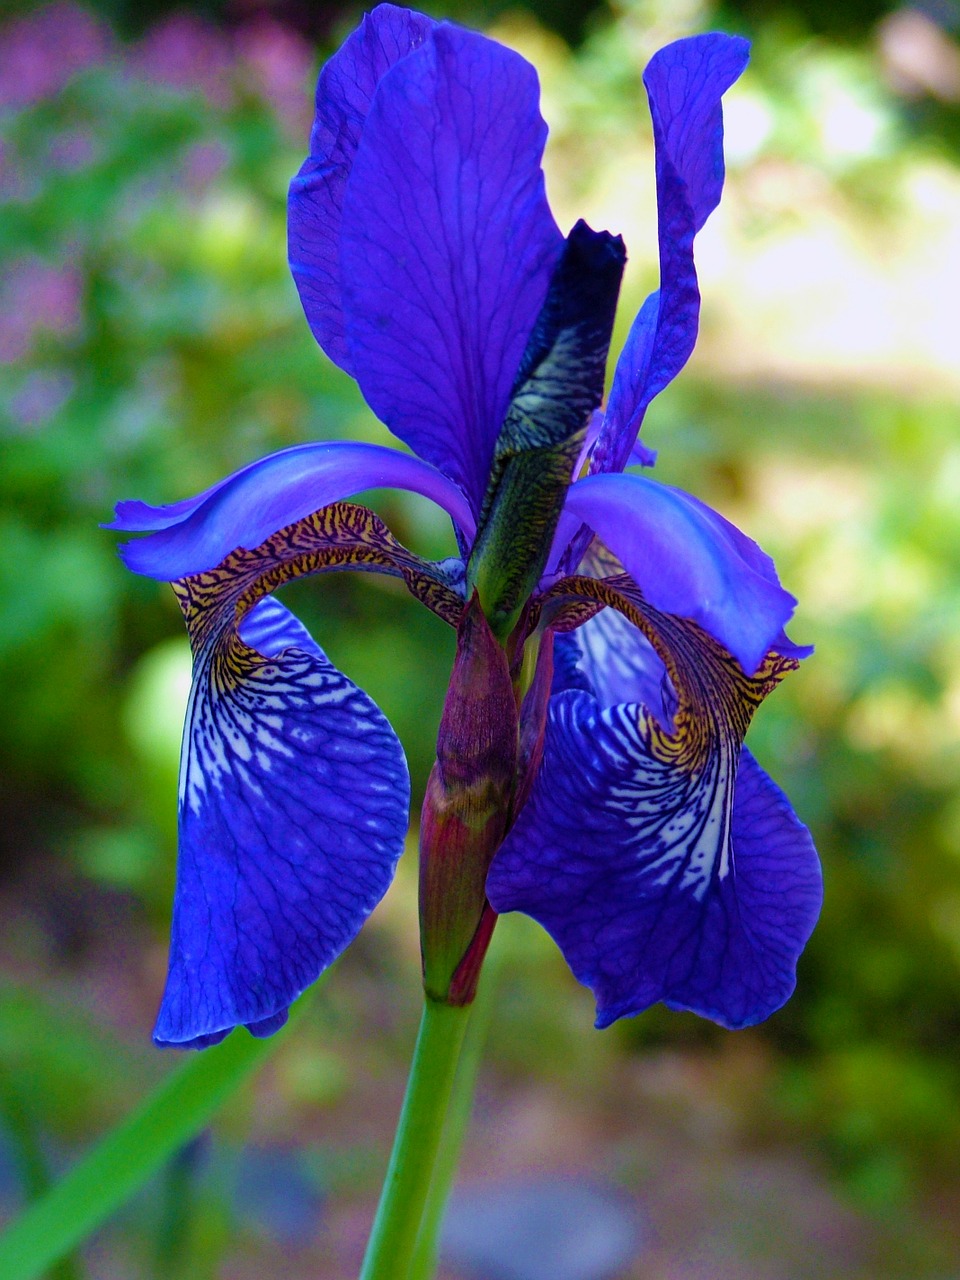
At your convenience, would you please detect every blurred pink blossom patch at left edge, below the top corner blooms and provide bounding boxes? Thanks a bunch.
[0,257,83,365]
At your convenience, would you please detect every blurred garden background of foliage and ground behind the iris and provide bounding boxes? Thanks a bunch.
[0,0,960,1280]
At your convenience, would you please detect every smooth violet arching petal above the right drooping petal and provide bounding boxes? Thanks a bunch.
[564,475,809,675]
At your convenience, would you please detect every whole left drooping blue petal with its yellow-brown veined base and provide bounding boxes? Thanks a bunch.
[155,506,462,1047]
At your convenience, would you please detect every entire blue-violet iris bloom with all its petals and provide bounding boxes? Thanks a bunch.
[111,5,820,1047]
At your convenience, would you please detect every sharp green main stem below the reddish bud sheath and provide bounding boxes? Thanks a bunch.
[360,996,471,1280]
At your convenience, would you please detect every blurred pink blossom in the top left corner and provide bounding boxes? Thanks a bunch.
[0,0,110,110]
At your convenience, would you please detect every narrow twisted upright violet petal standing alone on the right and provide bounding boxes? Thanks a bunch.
[590,35,749,472]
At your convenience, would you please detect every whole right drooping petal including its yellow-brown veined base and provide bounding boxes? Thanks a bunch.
[486,579,822,1027]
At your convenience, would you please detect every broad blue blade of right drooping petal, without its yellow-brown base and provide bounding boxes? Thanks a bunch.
[486,694,820,1027]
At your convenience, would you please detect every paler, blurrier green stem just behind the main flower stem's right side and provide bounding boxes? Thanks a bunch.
[408,951,499,1280]
